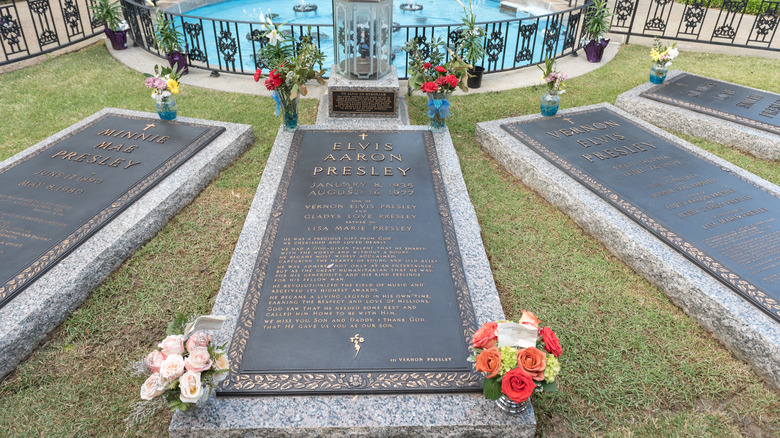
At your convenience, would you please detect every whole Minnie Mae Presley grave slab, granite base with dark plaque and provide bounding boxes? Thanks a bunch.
[0,108,254,377]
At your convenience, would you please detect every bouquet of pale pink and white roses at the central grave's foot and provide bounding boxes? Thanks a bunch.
[129,314,230,421]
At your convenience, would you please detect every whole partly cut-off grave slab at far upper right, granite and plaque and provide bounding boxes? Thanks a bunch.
[615,70,780,160]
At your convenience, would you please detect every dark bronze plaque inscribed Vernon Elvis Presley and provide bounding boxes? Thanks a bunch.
[502,108,780,321]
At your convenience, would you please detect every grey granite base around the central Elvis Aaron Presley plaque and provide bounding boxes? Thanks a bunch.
[169,126,536,437]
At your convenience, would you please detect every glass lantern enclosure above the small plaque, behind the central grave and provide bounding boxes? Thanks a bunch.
[333,0,393,79]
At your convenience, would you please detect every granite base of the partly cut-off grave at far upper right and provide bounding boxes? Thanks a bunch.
[615,70,780,160]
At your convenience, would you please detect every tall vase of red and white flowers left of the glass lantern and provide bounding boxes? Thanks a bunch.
[255,14,326,131]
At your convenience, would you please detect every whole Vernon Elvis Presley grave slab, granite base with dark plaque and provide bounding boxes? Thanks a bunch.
[477,104,780,387]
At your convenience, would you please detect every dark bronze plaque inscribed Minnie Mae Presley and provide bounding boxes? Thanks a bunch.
[0,114,225,307]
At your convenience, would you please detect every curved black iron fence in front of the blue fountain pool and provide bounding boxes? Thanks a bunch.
[121,0,587,77]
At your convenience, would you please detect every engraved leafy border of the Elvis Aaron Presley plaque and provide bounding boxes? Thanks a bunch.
[218,129,482,395]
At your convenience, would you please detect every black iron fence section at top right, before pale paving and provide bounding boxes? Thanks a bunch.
[611,0,780,51]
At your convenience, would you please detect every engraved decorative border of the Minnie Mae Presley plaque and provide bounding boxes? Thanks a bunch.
[0,113,225,308]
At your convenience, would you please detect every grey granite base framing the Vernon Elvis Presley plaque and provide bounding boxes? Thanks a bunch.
[476,103,780,388]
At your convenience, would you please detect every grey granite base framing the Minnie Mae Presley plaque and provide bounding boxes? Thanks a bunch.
[0,108,254,378]
